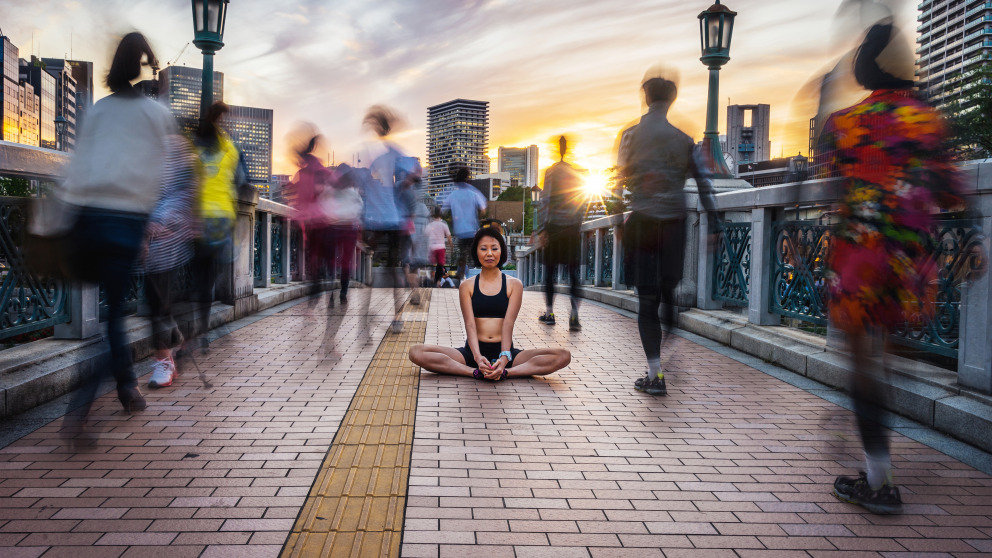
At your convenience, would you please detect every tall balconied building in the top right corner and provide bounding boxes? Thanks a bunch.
[916,0,992,107]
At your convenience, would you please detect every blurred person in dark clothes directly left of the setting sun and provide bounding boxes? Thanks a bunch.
[538,136,589,331]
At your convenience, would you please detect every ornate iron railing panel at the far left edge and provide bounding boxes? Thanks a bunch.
[0,197,70,339]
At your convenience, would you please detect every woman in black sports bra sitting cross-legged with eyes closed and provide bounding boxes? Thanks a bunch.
[410,227,572,381]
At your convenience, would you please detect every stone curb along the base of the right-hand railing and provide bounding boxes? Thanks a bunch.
[527,285,992,452]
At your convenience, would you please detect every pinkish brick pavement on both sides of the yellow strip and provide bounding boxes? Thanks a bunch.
[0,290,992,558]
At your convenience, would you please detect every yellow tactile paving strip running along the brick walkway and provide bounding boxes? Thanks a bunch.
[281,290,430,558]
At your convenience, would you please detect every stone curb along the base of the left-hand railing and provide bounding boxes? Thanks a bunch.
[0,283,334,418]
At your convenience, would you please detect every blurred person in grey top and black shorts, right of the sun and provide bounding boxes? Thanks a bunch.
[620,71,719,395]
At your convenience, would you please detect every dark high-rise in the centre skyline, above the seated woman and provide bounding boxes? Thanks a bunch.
[427,99,489,198]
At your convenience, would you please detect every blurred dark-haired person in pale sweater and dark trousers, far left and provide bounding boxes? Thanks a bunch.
[62,29,175,420]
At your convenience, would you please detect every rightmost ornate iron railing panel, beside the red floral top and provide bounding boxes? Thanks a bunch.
[891,219,985,358]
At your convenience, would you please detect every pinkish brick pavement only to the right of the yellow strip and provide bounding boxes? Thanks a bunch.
[402,291,992,558]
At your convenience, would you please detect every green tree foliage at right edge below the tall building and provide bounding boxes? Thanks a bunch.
[947,64,992,160]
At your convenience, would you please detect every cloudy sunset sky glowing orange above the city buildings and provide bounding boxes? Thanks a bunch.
[0,0,916,179]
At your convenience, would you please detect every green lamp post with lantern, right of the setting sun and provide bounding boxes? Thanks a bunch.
[699,0,737,178]
